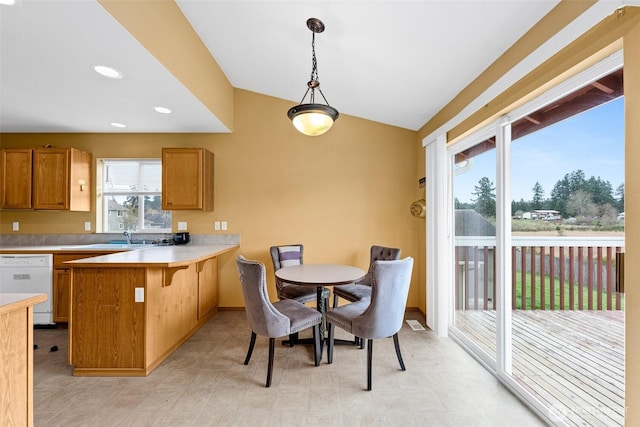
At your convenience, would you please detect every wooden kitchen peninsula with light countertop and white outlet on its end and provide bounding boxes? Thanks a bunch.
[66,245,238,376]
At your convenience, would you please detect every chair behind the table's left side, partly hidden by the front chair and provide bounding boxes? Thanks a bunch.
[269,243,331,308]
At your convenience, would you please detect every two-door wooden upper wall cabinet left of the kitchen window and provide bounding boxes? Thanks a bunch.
[0,148,92,212]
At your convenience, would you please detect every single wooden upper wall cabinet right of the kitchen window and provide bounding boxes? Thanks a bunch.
[162,148,213,211]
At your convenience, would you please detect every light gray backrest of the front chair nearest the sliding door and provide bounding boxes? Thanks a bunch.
[351,257,413,339]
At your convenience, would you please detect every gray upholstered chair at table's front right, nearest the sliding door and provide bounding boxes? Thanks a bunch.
[326,257,413,390]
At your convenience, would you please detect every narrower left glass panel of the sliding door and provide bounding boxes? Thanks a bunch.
[453,137,496,364]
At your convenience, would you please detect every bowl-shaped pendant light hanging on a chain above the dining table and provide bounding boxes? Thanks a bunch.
[287,18,339,136]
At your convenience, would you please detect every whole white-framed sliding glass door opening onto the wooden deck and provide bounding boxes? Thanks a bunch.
[448,55,624,426]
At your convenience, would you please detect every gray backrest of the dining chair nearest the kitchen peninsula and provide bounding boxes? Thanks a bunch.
[236,255,291,338]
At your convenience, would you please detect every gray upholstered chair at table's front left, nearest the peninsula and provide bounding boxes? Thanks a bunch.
[236,255,322,387]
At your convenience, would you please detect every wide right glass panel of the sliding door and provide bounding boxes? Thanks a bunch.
[511,88,624,426]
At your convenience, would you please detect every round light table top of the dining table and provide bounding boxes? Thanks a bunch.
[276,264,365,286]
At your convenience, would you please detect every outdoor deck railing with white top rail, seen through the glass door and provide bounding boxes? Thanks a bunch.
[455,236,624,310]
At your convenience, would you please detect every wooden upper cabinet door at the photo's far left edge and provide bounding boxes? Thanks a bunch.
[0,148,33,209]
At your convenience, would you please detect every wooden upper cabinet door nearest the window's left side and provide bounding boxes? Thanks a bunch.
[33,148,69,210]
